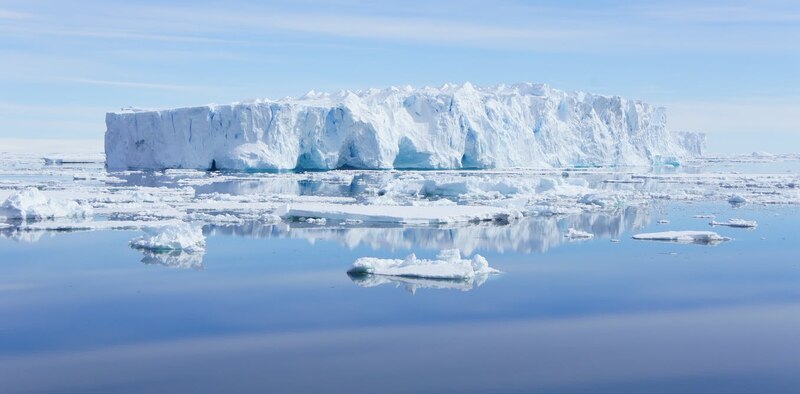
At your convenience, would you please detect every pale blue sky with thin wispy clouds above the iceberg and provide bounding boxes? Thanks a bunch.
[0,0,800,150]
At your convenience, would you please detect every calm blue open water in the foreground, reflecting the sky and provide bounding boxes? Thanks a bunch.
[0,178,800,393]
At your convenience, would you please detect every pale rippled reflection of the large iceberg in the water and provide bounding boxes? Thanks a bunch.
[209,207,652,254]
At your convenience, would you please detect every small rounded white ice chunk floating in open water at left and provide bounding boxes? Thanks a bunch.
[131,223,206,253]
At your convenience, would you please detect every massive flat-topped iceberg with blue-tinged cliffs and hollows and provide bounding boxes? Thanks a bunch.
[105,83,703,170]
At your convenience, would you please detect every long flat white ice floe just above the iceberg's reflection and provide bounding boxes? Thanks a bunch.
[276,203,522,225]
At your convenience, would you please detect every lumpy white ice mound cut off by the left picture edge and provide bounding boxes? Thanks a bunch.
[0,187,92,221]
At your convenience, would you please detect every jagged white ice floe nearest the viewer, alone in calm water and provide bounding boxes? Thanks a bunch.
[348,249,500,280]
